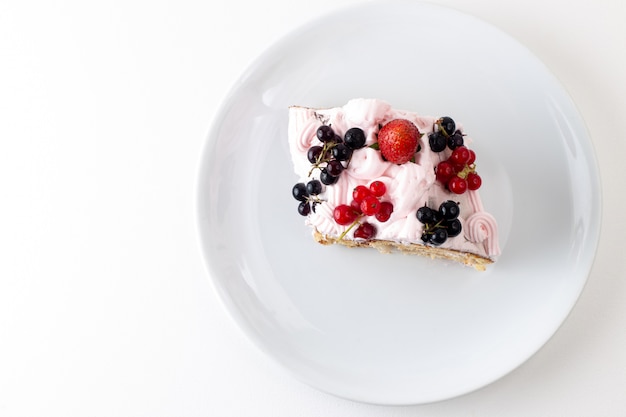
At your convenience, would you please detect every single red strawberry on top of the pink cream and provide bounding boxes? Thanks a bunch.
[378,119,420,164]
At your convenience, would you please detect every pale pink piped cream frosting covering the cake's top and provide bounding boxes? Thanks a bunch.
[288,99,500,259]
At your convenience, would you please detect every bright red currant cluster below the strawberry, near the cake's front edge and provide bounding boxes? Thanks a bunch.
[333,181,393,240]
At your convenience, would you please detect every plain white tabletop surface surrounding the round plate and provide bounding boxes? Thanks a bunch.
[0,0,626,416]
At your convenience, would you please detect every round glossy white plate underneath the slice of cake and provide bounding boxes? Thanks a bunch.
[197,1,601,404]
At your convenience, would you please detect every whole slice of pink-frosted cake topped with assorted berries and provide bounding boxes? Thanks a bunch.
[288,99,500,270]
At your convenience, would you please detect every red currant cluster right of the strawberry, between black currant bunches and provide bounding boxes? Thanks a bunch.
[435,146,482,194]
